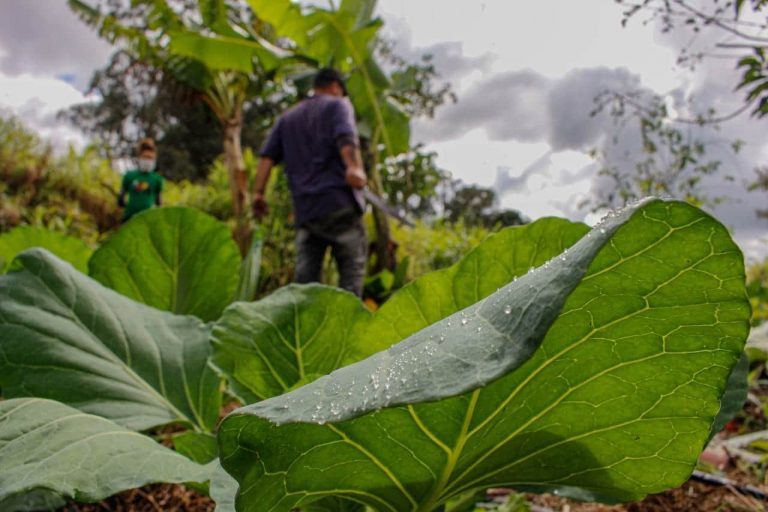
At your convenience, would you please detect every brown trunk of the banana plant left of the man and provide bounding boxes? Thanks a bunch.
[224,111,253,257]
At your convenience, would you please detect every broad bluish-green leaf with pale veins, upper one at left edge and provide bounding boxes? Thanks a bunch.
[0,249,221,430]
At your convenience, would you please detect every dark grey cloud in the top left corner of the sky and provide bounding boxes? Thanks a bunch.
[0,0,111,90]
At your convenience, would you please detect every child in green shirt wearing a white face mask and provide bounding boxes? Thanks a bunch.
[117,139,163,223]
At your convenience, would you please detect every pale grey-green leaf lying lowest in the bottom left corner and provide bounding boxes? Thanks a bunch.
[0,398,208,511]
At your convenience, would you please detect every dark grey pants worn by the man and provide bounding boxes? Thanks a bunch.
[295,209,368,297]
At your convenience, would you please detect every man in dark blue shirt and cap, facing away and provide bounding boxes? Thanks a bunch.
[253,68,368,296]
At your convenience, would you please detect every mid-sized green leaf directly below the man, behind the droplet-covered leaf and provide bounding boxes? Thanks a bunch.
[211,285,370,403]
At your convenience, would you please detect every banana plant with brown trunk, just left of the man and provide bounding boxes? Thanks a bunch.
[69,0,288,255]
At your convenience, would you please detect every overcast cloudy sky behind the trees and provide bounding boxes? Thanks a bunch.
[0,0,768,256]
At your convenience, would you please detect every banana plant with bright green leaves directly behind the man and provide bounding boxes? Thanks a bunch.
[162,0,410,272]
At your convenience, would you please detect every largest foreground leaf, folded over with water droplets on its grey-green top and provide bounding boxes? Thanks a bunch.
[219,201,749,512]
